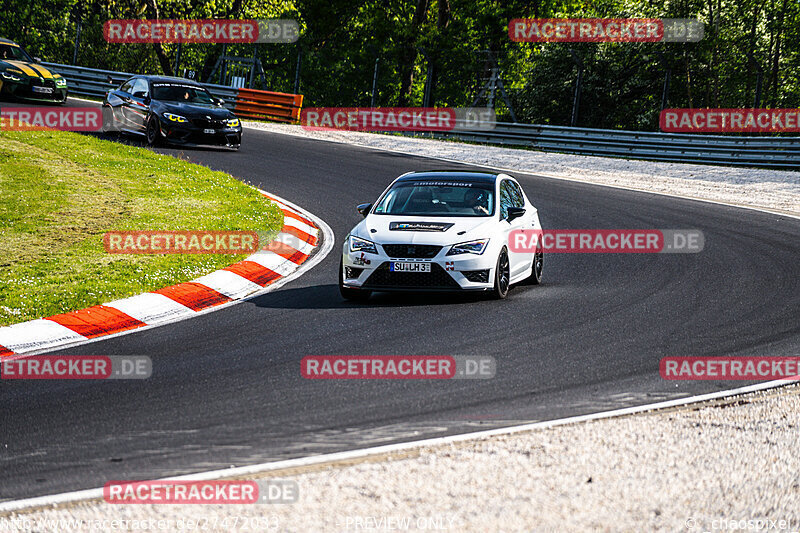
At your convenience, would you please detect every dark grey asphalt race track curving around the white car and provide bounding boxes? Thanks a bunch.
[0,98,800,500]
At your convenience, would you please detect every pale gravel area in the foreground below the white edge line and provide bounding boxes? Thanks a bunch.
[6,385,800,533]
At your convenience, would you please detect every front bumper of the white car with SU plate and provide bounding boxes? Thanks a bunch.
[342,239,497,292]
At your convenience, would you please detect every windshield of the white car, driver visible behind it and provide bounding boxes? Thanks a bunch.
[373,180,494,217]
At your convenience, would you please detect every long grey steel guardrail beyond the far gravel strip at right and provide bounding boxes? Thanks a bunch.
[414,122,800,170]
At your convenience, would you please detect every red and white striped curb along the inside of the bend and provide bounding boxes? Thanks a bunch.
[0,191,334,357]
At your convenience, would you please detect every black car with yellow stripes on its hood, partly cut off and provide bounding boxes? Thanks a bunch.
[0,39,67,104]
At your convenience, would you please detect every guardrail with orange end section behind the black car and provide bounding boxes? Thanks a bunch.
[42,63,303,122]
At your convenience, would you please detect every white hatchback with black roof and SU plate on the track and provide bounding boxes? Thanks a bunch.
[339,171,543,300]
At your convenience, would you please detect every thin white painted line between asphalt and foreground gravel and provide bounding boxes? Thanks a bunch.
[0,380,800,513]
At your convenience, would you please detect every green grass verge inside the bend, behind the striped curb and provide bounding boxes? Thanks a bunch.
[0,131,283,326]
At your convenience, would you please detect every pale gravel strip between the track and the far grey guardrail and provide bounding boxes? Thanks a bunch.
[245,122,800,214]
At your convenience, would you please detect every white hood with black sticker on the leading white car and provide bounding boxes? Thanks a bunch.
[353,215,496,244]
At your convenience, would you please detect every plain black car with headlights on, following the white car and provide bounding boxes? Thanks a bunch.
[103,76,242,149]
